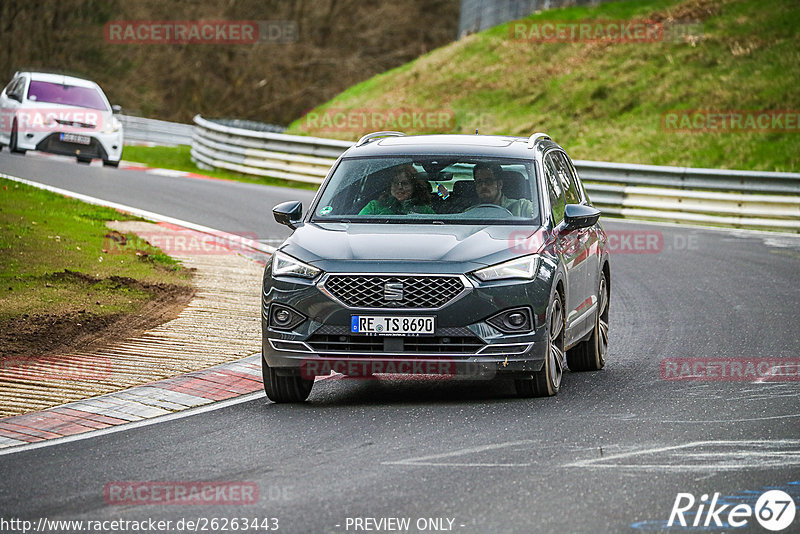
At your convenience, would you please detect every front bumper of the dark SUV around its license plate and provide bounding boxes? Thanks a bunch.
[261,264,550,378]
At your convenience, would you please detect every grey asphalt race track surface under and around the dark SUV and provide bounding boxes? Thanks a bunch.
[0,151,800,534]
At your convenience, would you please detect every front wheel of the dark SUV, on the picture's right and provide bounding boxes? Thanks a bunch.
[514,292,564,397]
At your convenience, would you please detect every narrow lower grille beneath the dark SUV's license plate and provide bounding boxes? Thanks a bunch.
[306,334,484,354]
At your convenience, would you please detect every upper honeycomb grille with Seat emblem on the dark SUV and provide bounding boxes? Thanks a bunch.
[324,274,465,309]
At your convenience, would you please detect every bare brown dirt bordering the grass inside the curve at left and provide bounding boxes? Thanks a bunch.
[0,269,195,357]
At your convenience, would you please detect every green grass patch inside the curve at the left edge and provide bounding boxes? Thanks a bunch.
[0,179,191,321]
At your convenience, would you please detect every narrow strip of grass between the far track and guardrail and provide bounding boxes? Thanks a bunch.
[122,145,318,191]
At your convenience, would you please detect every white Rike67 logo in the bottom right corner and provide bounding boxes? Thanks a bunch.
[667,490,796,532]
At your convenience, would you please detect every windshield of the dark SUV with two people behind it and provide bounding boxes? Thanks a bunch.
[311,156,539,224]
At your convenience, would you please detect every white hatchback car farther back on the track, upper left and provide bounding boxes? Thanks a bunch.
[0,72,122,167]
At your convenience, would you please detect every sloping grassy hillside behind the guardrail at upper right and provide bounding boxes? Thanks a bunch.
[287,0,800,171]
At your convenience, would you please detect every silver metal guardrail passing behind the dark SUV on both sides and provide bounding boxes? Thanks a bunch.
[191,115,800,232]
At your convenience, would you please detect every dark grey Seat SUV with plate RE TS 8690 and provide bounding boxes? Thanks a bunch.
[262,132,611,402]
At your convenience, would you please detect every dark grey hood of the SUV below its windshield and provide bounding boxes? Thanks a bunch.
[283,223,540,270]
